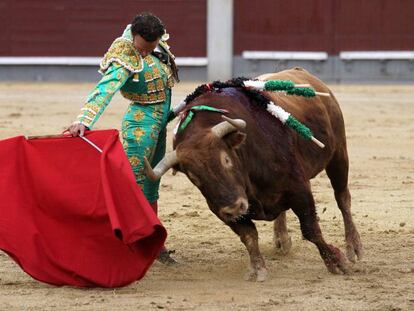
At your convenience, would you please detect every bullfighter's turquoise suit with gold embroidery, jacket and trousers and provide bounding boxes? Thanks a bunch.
[76,25,174,202]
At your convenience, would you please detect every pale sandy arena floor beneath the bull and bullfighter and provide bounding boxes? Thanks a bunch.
[0,79,414,311]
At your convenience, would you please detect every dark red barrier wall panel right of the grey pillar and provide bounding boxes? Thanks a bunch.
[234,0,414,54]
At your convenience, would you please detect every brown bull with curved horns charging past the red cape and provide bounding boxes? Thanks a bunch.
[146,68,362,281]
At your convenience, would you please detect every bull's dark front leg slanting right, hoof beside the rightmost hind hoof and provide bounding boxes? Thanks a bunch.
[285,185,348,273]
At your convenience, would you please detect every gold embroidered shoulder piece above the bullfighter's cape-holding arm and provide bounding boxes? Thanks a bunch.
[99,37,144,74]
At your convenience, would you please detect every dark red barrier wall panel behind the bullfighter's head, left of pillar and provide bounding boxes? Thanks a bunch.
[0,0,207,56]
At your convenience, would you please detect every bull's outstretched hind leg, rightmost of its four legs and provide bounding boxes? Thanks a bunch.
[326,150,363,262]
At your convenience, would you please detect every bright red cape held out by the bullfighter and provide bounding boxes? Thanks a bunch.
[0,130,166,287]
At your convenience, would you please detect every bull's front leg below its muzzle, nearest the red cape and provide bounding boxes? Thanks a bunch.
[228,218,267,282]
